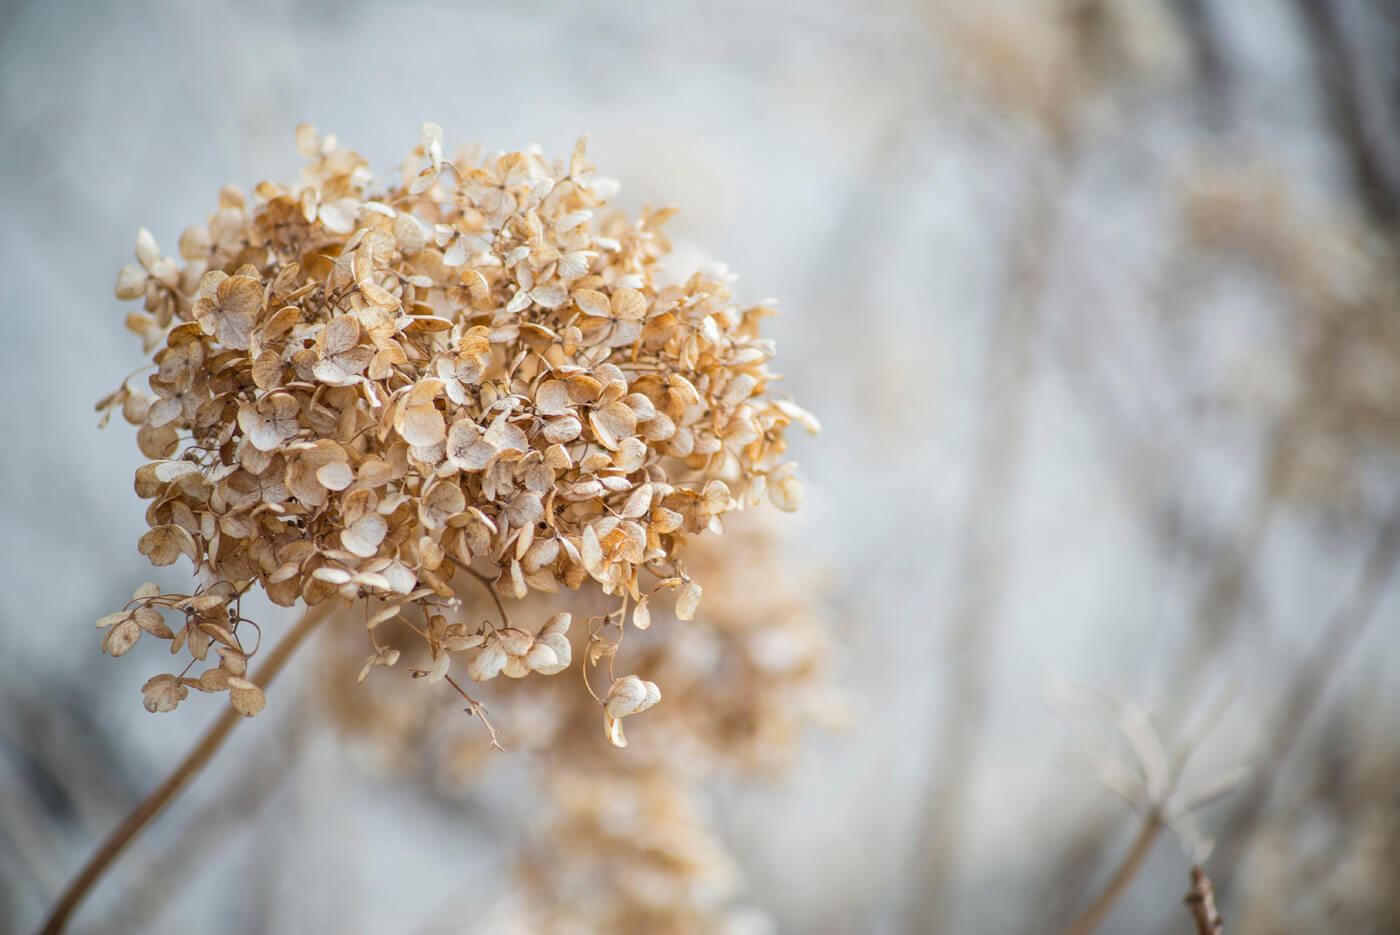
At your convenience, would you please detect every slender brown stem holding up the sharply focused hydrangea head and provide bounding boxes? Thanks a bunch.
[39,600,333,935]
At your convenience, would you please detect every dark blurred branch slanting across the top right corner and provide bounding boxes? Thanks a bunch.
[1298,0,1400,228]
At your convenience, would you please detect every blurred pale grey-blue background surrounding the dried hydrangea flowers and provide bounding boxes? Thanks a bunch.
[0,0,1400,935]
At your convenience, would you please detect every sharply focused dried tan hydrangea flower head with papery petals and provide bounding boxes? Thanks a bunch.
[99,125,816,743]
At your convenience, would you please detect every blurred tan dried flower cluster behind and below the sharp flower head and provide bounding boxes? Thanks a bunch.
[321,514,844,932]
